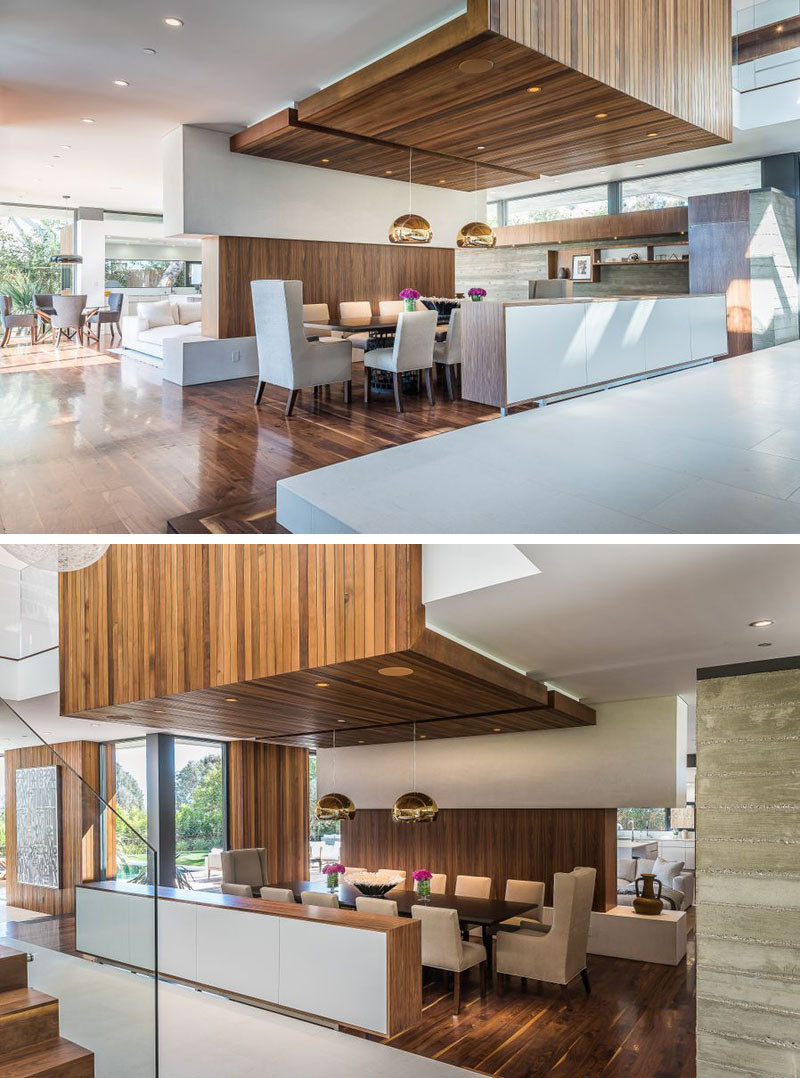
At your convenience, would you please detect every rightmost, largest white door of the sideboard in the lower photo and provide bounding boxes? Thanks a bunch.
[279,917,387,1033]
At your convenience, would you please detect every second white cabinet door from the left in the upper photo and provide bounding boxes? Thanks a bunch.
[587,300,649,386]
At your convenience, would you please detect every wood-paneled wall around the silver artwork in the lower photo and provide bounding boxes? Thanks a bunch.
[4,742,115,915]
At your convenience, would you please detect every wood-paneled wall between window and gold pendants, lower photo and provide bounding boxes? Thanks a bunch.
[227,742,308,883]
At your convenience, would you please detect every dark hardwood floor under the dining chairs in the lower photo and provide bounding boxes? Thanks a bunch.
[373,941,695,1078]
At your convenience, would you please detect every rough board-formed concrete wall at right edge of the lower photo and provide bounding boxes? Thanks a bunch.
[696,669,800,1078]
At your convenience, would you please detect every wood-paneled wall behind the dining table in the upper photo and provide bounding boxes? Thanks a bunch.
[203,238,455,337]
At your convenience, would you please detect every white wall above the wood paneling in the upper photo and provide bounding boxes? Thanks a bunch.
[164,126,478,247]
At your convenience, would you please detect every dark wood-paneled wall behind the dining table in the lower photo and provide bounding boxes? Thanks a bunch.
[342,809,617,910]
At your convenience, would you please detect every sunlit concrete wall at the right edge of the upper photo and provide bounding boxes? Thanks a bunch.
[749,190,798,350]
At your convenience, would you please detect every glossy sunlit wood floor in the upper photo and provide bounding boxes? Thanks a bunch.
[0,337,497,534]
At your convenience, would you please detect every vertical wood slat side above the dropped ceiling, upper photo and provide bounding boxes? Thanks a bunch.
[489,0,733,140]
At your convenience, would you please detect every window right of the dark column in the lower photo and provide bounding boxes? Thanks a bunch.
[175,737,224,883]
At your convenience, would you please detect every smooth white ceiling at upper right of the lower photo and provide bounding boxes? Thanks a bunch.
[426,542,800,703]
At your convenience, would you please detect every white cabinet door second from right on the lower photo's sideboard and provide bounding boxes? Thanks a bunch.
[197,906,280,996]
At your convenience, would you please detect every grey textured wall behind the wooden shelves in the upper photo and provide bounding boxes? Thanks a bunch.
[456,236,689,300]
